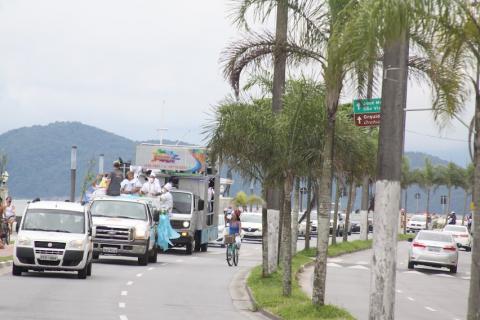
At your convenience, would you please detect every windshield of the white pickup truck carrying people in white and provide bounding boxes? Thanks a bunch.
[90,200,147,220]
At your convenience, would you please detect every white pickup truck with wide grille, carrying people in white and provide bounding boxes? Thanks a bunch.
[89,196,159,266]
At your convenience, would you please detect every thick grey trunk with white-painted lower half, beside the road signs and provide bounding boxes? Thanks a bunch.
[369,26,409,320]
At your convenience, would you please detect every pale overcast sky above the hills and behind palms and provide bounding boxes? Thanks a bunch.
[0,0,473,165]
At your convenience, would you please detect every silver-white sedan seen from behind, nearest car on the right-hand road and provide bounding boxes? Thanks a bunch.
[408,230,458,273]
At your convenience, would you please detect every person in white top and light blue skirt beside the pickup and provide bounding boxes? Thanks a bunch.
[157,184,180,251]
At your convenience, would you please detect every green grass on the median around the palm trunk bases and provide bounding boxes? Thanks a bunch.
[247,254,355,320]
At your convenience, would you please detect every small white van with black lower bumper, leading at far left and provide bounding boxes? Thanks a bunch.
[12,201,93,279]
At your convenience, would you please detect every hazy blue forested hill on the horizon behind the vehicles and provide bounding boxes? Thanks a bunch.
[0,122,470,212]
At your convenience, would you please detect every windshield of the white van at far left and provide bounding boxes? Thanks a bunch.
[22,209,85,233]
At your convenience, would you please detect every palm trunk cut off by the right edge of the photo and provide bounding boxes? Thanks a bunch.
[467,59,480,320]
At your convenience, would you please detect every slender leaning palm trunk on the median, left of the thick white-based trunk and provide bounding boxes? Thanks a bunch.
[312,109,338,306]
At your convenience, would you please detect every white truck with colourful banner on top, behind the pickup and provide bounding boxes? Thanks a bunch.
[135,143,220,254]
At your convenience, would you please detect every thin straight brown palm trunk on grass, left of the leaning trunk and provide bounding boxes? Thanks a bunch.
[282,172,294,297]
